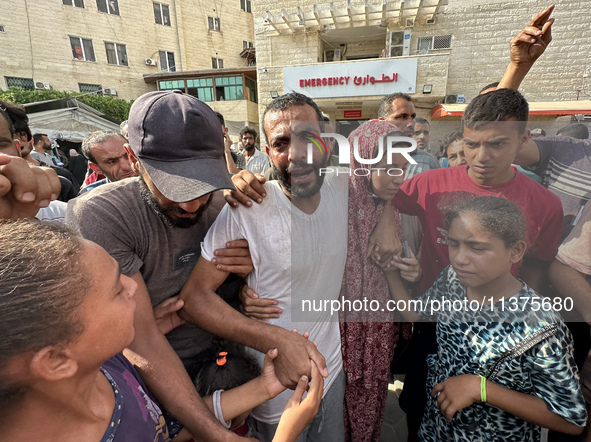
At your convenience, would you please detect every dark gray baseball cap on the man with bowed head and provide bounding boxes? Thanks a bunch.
[128,90,234,203]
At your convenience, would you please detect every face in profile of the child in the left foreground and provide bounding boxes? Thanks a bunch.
[71,241,137,365]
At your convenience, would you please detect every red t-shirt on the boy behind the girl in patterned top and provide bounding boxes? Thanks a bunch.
[393,166,562,293]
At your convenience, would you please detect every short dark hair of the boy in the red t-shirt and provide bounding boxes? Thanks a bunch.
[462,89,529,134]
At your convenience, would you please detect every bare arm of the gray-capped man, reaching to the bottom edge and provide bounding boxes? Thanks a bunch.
[125,272,243,441]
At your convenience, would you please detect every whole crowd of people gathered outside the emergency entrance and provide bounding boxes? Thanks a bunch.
[0,3,591,442]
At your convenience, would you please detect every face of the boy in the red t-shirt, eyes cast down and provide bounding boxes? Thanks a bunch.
[464,120,529,186]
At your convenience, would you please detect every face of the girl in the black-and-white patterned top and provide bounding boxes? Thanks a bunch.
[447,213,521,288]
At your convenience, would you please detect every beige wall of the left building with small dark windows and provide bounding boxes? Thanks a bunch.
[0,0,254,100]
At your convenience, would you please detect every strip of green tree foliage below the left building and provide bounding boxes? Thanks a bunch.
[0,87,133,121]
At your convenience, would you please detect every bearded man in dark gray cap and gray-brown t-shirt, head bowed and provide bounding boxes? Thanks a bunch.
[66,91,302,440]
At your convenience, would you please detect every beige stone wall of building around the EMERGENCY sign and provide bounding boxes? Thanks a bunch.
[255,0,591,126]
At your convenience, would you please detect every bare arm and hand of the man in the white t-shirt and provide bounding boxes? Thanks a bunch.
[180,257,328,388]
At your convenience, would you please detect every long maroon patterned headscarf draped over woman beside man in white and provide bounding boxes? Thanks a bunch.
[341,120,410,388]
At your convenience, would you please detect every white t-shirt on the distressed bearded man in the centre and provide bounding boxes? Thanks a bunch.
[201,174,348,424]
